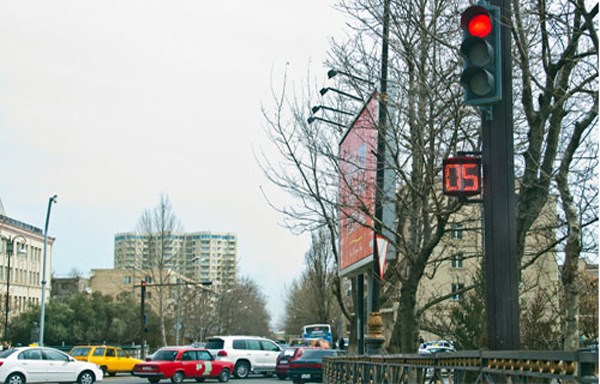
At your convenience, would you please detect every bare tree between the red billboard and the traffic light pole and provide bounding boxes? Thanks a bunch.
[263,1,478,352]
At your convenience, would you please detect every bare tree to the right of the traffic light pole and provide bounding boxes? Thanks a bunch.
[513,0,598,350]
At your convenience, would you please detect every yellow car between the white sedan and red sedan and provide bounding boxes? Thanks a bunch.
[69,345,142,376]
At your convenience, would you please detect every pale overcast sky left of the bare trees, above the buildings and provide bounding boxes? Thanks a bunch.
[0,0,344,328]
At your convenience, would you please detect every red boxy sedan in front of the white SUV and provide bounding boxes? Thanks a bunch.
[132,347,233,383]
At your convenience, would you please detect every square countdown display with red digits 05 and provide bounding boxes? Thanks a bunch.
[443,156,481,196]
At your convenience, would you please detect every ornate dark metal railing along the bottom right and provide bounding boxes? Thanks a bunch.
[323,350,598,384]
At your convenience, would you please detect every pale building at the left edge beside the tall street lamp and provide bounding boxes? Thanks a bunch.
[0,214,54,323]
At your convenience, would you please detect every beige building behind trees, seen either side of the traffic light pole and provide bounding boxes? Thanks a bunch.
[417,201,560,338]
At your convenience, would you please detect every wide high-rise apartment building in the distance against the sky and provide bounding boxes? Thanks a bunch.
[114,232,237,286]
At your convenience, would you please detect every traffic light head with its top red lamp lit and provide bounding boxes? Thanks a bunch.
[460,5,502,106]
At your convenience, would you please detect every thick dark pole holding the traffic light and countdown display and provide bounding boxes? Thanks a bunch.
[482,0,519,350]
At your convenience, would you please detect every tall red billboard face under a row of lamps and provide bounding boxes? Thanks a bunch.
[339,93,379,274]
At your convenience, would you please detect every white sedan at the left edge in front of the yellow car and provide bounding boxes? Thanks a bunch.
[0,347,104,384]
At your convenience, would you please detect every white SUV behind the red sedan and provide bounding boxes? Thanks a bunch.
[204,336,281,379]
